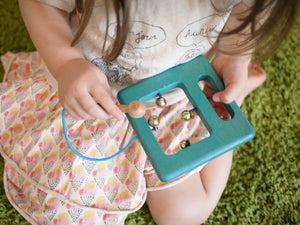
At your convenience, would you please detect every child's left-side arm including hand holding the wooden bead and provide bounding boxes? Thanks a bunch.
[19,0,122,119]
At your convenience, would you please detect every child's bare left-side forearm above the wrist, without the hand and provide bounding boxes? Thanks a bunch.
[19,0,84,79]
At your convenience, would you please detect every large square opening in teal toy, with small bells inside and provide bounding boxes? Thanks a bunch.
[145,85,210,155]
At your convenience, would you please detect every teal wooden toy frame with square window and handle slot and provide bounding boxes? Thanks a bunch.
[118,56,255,182]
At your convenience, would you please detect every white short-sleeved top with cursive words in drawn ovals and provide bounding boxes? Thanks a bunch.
[40,0,252,103]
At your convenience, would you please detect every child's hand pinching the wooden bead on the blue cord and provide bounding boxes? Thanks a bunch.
[56,58,123,119]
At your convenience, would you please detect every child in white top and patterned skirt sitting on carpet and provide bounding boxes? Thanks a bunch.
[0,0,297,224]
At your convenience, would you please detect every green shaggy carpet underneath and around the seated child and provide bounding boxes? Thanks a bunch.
[0,0,300,225]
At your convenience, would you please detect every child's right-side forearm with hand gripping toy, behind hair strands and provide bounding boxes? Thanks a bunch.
[212,2,265,104]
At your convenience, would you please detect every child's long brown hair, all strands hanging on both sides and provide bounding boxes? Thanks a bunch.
[71,0,299,61]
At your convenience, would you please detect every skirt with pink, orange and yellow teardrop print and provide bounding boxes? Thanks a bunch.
[0,52,209,224]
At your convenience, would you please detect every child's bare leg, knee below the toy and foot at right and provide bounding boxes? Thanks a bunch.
[147,64,266,225]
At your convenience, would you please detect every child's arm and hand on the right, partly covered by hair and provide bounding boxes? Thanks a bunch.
[212,2,263,103]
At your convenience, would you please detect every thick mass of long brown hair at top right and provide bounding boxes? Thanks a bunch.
[216,0,299,62]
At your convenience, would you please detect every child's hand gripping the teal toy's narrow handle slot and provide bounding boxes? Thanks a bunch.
[212,53,251,104]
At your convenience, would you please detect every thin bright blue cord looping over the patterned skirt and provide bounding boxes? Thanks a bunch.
[62,109,136,162]
